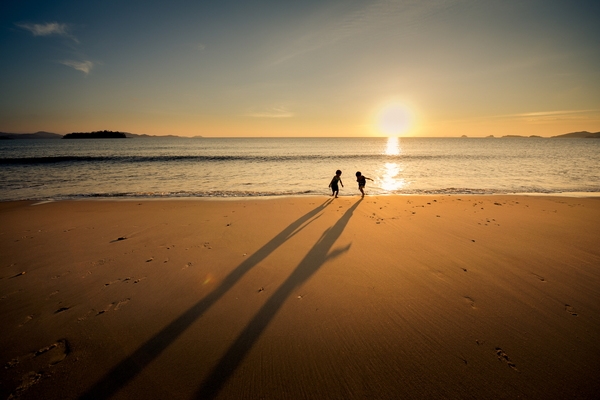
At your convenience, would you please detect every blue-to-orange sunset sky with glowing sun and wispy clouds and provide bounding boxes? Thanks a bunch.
[0,0,600,137]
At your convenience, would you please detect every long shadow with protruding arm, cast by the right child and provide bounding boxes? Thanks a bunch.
[195,198,362,399]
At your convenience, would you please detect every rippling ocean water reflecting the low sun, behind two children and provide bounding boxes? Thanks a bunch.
[0,138,600,201]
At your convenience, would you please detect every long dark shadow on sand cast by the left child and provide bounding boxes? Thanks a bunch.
[79,199,332,400]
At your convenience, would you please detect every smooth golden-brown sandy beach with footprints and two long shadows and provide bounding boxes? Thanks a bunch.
[0,195,600,399]
